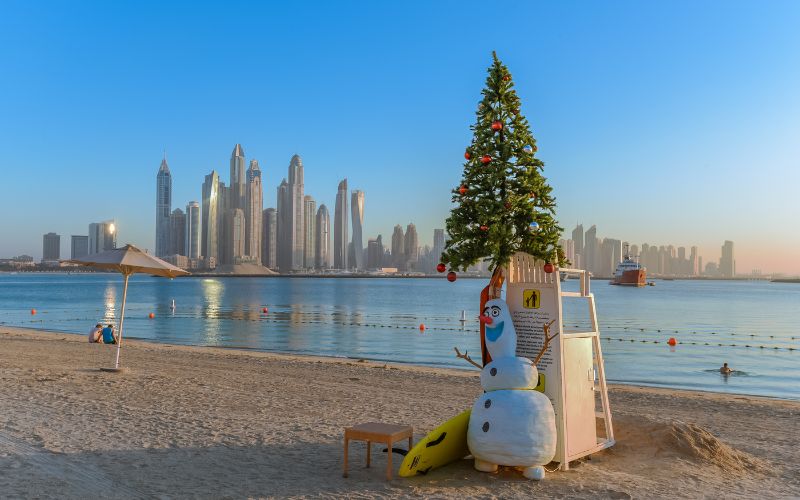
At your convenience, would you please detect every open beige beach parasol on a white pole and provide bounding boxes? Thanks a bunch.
[66,244,189,371]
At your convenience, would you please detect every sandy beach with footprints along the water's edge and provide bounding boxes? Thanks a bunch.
[0,327,800,498]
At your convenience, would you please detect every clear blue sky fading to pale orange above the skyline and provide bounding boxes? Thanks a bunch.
[0,0,800,273]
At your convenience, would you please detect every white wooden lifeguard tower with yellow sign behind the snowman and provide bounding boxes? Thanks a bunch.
[481,253,615,470]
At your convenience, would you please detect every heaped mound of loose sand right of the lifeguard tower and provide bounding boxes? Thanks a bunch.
[614,417,769,473]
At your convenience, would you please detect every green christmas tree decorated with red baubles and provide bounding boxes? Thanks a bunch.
[439,52,567,277]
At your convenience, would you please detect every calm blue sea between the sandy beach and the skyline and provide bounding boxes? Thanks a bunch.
[0,274,800,399]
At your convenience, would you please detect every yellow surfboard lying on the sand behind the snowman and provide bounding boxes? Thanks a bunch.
[399,410,472,477]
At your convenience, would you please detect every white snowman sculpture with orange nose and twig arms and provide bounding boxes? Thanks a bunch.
[467,299,557,480]
